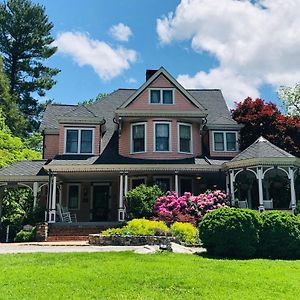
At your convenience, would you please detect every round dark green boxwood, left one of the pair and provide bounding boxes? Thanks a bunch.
[199,208,261,258]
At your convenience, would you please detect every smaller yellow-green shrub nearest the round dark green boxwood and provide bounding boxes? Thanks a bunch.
[171,222,199,245]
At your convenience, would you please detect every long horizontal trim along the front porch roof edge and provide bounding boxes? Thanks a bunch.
[44,164,221,173]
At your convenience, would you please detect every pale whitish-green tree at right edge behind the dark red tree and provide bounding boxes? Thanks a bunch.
[278,83,300,116]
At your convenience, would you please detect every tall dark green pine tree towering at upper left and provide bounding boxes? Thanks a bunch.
[0,0,59,133]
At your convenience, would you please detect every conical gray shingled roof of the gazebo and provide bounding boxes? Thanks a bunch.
[225,136,300,168]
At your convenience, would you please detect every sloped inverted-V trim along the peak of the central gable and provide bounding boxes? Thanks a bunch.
[120,67,206,110]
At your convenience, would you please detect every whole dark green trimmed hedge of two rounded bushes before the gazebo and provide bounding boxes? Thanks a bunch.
[199,208,300,259]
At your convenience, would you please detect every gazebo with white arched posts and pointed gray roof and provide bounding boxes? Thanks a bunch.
[224,137,300,212]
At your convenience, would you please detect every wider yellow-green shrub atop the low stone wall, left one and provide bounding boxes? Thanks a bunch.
[102,219,169,236]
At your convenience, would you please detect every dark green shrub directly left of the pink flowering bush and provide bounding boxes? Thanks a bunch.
[126,184,163,219]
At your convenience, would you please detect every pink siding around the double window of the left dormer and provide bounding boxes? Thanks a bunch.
[59,124,101,155]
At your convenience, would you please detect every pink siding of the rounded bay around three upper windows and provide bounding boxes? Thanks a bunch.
[119,118,202,159]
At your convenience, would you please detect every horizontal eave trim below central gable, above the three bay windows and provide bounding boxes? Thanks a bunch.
[116,108,207,118]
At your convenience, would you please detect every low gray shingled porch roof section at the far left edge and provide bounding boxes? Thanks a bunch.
[0,159,47,177]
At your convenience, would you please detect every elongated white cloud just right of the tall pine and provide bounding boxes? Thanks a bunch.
[54,32,137,80]
